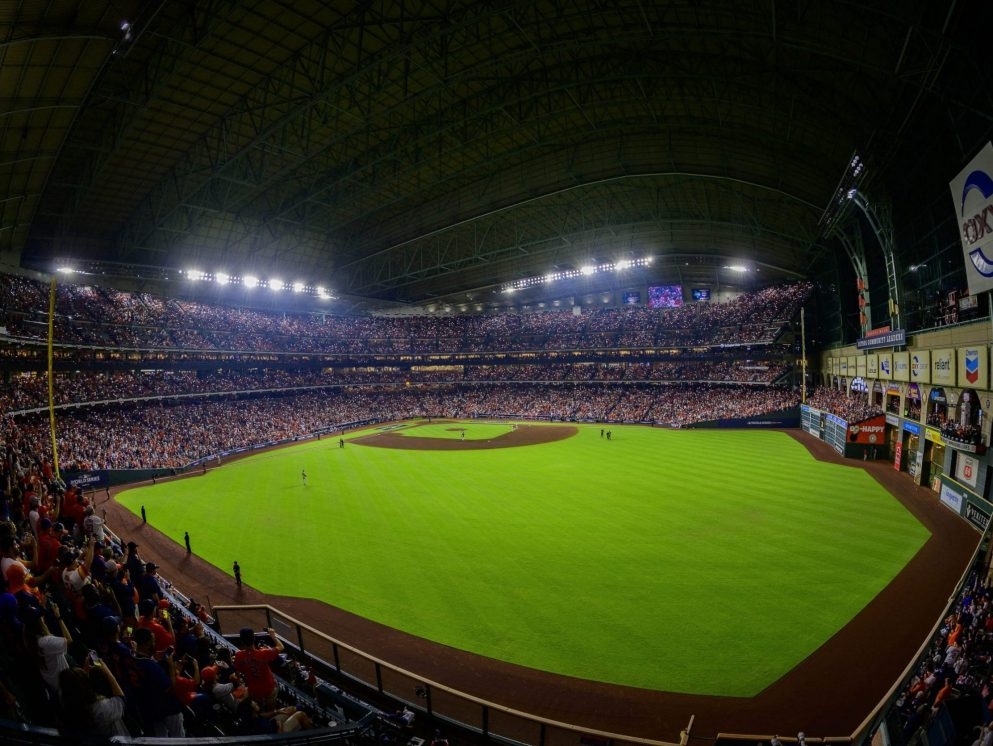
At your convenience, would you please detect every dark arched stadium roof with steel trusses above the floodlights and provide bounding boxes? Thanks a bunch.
[0,0,993,307]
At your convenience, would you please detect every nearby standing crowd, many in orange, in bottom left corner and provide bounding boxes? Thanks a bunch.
[0,454,335,742]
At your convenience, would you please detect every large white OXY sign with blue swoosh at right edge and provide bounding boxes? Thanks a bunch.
[948,143,993,295]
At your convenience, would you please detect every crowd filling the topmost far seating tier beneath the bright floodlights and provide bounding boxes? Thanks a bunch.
[0,274,812,354]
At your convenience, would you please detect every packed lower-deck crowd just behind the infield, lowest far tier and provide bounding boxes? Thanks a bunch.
[0,383,799,470]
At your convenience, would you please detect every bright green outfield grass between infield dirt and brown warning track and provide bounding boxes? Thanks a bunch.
[119,422,928,696]
